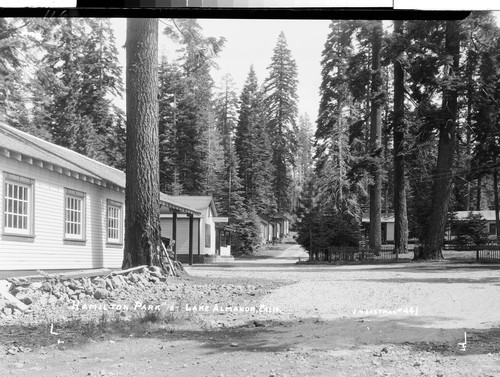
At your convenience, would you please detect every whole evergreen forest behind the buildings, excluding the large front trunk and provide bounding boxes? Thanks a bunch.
[0,12,500,259]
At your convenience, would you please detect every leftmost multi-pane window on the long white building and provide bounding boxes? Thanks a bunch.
[3,173,34,236]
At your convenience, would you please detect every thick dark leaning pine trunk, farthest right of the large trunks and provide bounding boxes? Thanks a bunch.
[420,21,460,259]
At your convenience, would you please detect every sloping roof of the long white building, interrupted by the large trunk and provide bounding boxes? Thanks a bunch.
[0,122,199,214]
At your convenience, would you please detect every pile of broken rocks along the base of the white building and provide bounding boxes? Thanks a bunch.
[0,266,167,318]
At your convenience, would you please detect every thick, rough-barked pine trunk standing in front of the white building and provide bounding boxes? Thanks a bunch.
[122,18,161,268]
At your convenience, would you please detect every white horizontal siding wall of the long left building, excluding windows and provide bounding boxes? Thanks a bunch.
[0,156,125,270]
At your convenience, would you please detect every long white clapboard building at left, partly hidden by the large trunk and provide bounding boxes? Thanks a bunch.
[0,123,200,271]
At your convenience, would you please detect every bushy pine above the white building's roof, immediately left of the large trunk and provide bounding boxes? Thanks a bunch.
[35,18,124,164]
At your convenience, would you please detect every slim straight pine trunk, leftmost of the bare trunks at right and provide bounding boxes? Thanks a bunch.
[369,21,383,254]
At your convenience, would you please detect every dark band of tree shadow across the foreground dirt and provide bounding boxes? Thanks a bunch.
[0,315,500,356]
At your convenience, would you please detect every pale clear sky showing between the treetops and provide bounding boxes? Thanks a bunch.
[112,19,330,121]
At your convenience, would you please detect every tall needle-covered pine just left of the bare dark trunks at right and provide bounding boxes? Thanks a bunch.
[314,21,361,217]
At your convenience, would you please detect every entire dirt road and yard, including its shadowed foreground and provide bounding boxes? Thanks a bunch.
[0,239,500,376]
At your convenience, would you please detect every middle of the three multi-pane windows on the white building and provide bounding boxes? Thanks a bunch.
[64,189,85,240]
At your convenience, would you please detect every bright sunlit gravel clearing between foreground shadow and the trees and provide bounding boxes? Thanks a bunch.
[188,245,500,328]
